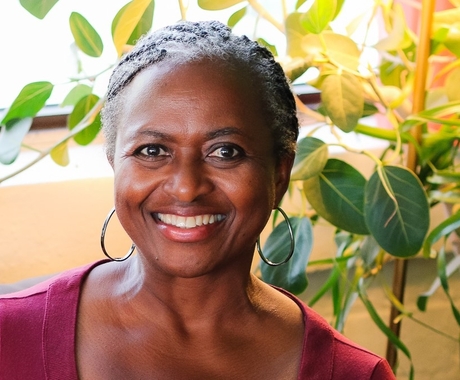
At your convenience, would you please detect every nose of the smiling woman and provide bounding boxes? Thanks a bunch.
[164,161,213,202]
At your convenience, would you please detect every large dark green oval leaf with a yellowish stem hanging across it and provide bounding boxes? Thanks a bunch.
[364,166,430,257]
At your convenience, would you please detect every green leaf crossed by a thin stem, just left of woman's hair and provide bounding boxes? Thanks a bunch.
[68,94,101,145]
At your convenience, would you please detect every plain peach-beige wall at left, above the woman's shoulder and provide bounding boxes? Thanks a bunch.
[0,178,130,283]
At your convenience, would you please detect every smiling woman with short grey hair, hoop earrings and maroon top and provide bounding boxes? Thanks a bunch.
[0,22,394,380]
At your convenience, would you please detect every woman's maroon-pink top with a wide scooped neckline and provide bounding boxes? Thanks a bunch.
[0,261,395,380]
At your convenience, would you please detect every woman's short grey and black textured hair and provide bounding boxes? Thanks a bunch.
[102,21,299,161]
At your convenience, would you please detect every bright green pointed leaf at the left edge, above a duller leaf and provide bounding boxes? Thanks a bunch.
[1,82,53,125]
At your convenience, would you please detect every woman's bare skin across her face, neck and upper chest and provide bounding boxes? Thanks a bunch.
[76,61,304,380]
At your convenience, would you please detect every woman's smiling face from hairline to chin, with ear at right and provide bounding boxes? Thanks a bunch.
[113,61,292,277]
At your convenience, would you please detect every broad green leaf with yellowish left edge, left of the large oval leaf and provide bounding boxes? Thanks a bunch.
[303,158,369,235]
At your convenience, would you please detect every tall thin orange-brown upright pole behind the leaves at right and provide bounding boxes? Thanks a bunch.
[386,0,436,368]
